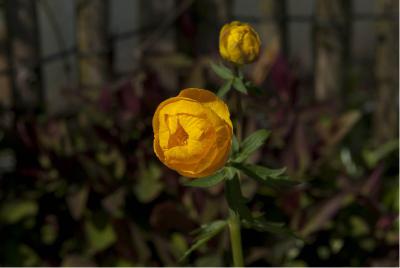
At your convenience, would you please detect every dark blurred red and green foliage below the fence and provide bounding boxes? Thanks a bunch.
[0,43,399,266]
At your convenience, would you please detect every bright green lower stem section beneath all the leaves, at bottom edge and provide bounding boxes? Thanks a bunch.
[228,209,243,267]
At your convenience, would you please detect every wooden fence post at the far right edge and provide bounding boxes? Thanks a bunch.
[373,0,399,145]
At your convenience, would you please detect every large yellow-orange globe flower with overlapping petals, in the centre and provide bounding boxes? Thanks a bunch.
[153,88,232,178]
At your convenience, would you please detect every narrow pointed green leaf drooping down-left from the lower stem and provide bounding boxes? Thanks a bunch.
[179,220,228,262]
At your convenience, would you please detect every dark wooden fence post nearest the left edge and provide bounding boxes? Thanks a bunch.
[5,0,44,111]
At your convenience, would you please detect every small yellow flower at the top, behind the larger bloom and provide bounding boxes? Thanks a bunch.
[219,21,261,64]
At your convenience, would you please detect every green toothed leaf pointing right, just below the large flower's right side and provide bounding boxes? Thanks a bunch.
[232,163,301,189]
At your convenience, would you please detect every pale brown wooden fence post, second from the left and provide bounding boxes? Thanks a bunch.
[76,0,112,89]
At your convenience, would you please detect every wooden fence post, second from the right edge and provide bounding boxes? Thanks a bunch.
[315,0,351,101]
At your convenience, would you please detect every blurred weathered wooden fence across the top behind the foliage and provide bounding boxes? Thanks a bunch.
[0,0,399,144]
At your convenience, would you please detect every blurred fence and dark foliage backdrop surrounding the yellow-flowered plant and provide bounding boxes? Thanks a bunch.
[0,0,399,266]
